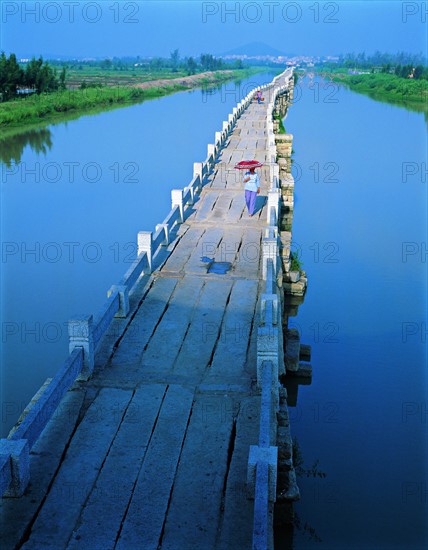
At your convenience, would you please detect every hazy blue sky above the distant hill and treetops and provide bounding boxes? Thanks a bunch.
[0,0,428,57]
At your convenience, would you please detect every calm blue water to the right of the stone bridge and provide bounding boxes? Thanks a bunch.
[285,79,428,549]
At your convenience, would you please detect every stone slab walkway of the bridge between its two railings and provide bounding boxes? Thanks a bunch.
[2,82,282,550]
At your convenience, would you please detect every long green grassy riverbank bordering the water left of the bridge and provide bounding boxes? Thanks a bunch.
[0,67,274,136]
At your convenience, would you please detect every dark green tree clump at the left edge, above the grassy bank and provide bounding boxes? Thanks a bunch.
[0,52,66,101]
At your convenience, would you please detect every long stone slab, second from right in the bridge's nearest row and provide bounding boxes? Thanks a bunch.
[161,395,237,550]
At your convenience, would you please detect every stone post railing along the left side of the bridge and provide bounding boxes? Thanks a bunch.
[0,76,256,497]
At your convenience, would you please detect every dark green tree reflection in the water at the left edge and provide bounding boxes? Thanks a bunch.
[0,128,53,168]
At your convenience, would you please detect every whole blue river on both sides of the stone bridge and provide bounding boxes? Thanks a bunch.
[1,74,428,550]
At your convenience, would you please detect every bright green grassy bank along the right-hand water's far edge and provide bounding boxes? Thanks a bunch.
[319,71,428,112]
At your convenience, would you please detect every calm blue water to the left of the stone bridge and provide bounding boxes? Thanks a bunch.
[0,73,275,435]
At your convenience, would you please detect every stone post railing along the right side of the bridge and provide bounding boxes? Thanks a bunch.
[247,69,292,550]
